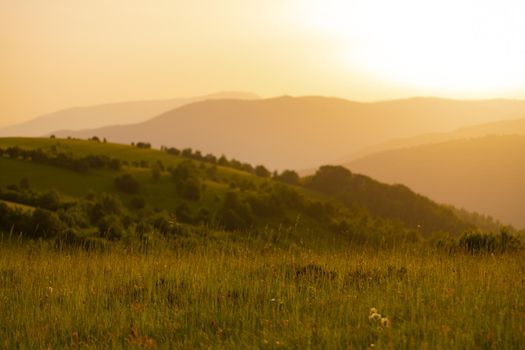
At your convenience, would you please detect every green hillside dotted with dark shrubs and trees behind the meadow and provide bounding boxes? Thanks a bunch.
[0,138,496,245]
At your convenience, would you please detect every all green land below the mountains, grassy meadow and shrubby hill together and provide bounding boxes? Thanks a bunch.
[0,138,525,349]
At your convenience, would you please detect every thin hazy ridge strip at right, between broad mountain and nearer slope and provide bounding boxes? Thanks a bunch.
[345,118,525,162]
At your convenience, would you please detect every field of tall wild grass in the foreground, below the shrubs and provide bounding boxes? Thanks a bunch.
[0,240,525,349]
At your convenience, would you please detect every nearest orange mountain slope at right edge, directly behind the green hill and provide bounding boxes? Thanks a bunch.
[346,135,525,228]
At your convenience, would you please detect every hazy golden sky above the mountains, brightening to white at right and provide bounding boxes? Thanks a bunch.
[0,0,525,125]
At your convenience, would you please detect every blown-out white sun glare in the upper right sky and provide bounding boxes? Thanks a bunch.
[301,0,525,95]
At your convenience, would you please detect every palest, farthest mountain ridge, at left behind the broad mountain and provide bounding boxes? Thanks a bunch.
[0,92,259,136]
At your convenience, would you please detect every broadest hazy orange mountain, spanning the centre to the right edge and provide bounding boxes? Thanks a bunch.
[56,97,525,169]
